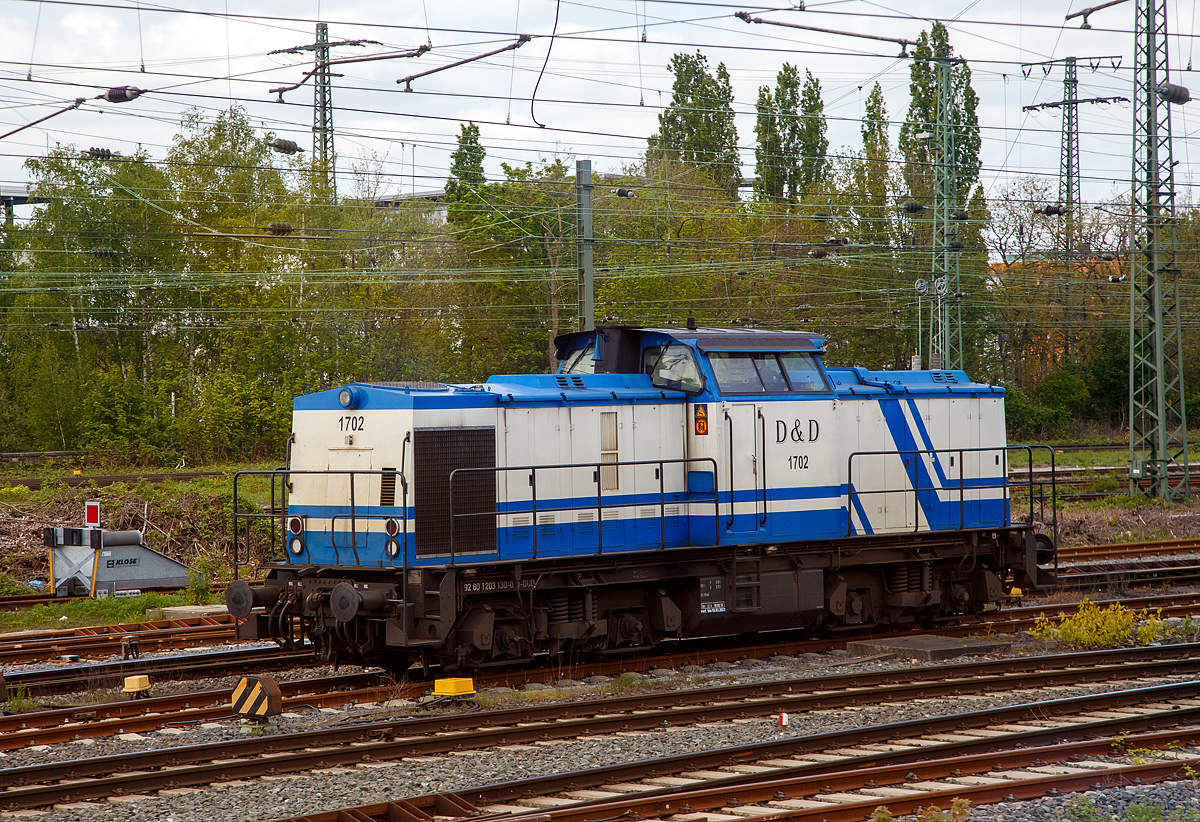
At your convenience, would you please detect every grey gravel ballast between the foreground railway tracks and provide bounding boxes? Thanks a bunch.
[0,652,1195,822]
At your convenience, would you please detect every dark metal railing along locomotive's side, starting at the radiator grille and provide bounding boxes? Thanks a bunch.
[450,457,720,564]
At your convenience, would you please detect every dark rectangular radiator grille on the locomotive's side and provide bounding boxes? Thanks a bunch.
[413,427,496,557]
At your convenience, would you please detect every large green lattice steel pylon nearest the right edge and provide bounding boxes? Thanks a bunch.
[1129,0,1192,499]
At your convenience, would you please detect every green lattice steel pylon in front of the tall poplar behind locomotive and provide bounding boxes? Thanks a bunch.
[931,58,962,368]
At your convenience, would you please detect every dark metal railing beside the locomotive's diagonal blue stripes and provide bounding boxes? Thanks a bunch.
[846,445,1058,545]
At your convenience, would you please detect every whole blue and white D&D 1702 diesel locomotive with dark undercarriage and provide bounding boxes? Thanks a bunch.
[227,326,1054,667]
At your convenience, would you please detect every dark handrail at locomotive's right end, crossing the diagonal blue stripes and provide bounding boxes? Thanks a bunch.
[846,444,1058,537]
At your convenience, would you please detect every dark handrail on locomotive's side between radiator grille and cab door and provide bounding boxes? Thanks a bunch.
[449,457,721,565]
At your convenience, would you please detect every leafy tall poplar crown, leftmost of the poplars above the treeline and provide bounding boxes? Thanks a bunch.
[648,52,742,199]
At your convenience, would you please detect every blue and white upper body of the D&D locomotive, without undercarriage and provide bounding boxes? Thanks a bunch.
[287,329,1010,568]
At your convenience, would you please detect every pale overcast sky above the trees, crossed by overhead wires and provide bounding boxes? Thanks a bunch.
[0,0,1200,216]
